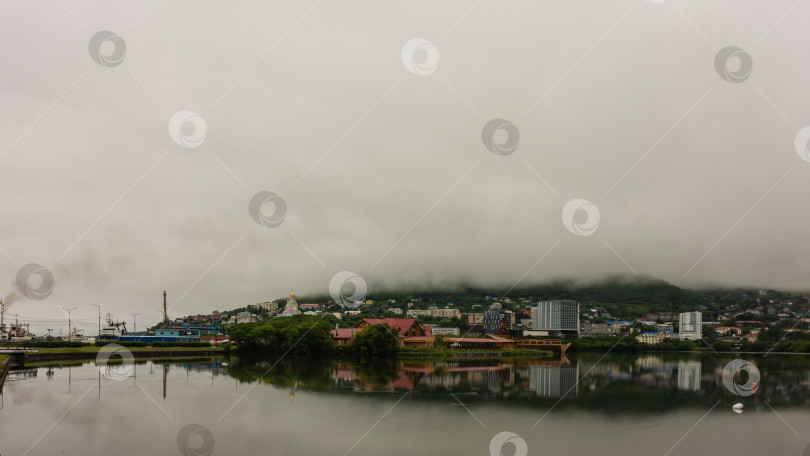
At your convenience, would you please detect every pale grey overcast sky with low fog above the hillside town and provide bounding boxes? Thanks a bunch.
[0,0,810,334]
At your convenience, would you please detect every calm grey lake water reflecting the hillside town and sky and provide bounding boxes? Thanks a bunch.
[0,354,810,456]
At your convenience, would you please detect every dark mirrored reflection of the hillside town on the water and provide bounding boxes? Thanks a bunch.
[8,354,810,411]
